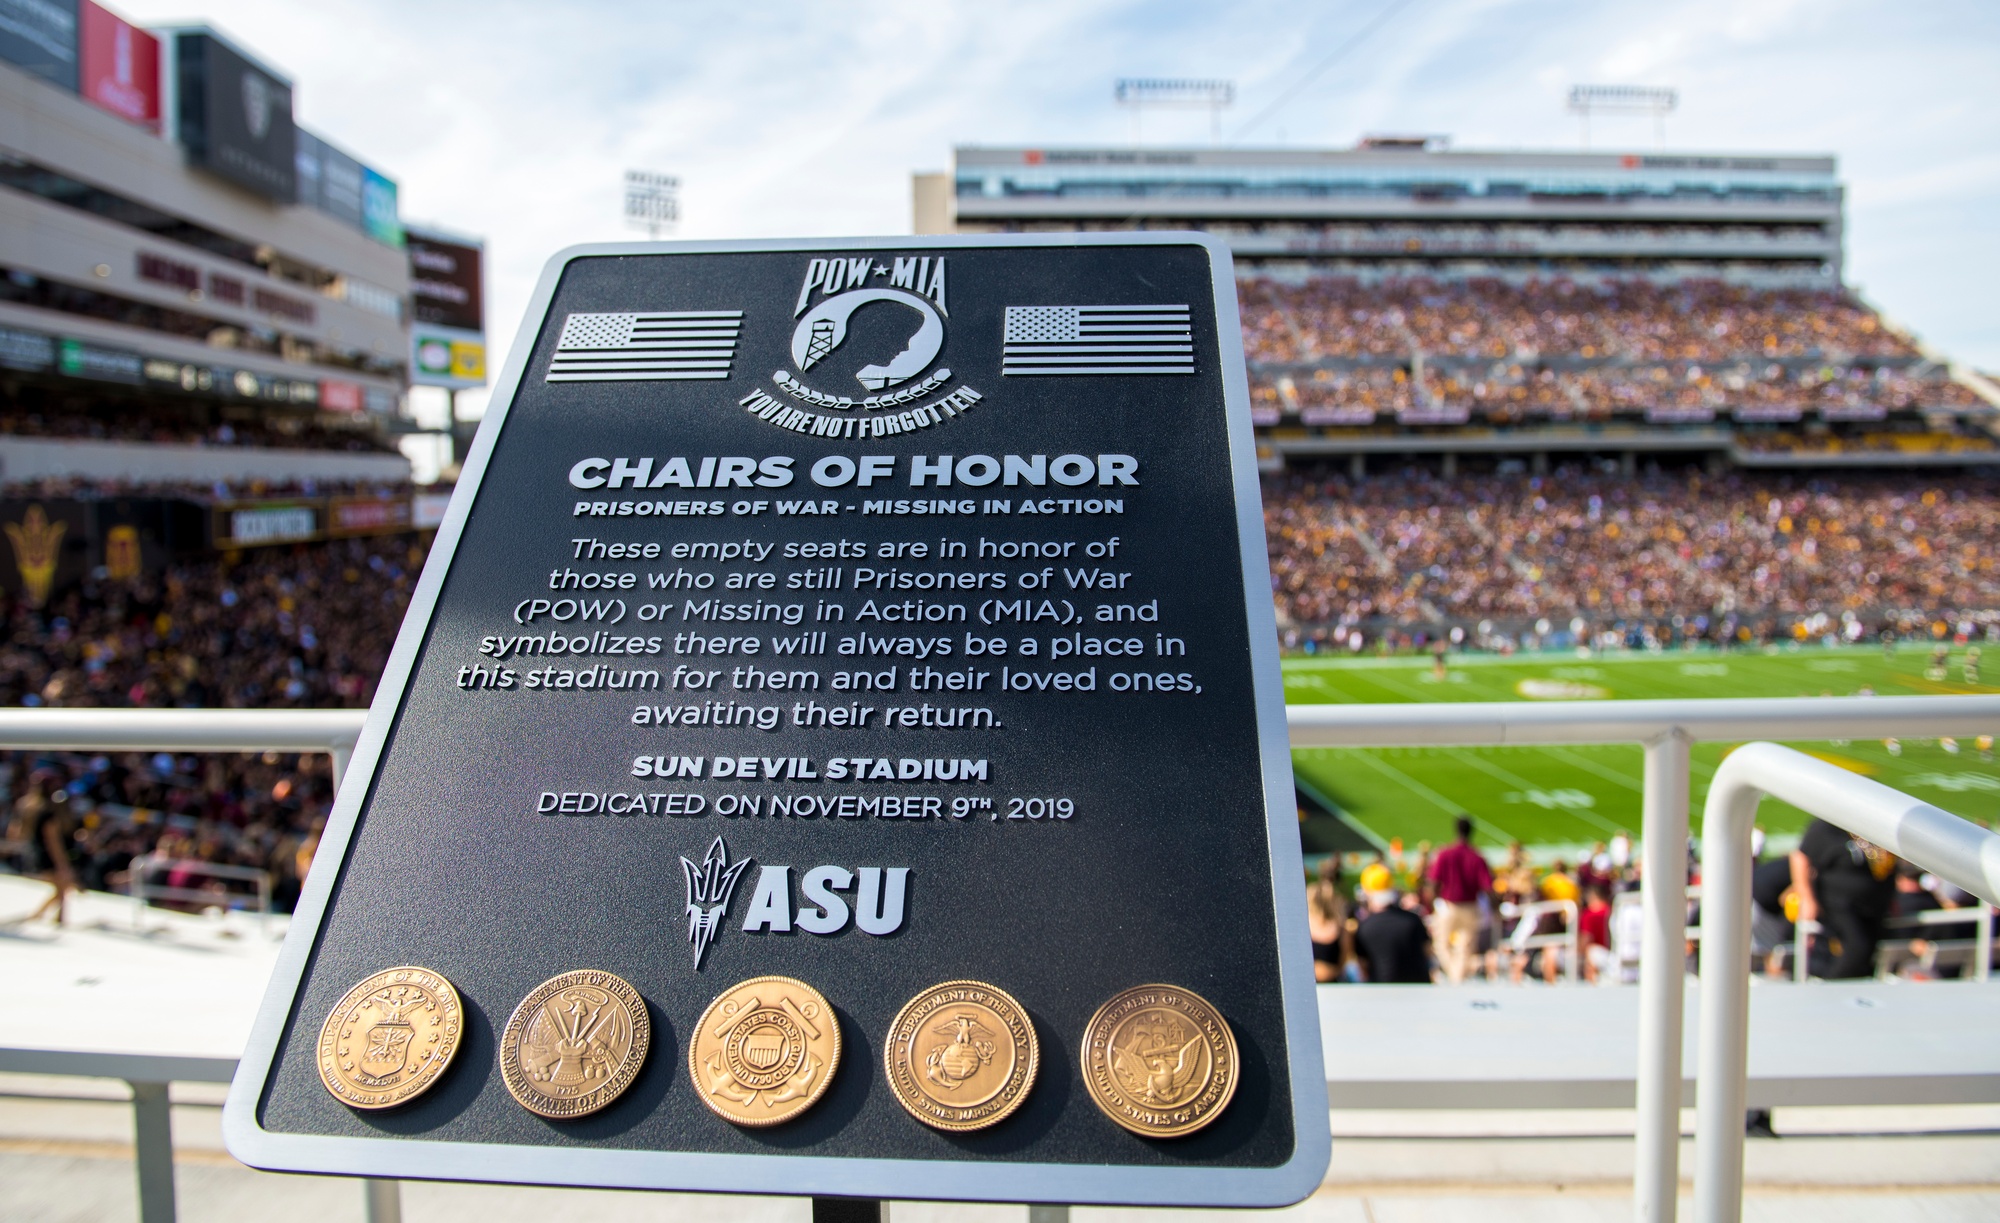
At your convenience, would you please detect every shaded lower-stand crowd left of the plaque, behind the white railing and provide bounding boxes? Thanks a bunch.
[0,536,424,909]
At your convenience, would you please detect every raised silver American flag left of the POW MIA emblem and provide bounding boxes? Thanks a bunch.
[548,310,744,382]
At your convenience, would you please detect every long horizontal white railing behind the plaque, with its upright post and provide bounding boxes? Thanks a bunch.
[0,695,2000,1223]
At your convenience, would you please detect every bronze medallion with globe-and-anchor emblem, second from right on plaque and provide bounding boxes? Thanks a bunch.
[882,981,1040,1131]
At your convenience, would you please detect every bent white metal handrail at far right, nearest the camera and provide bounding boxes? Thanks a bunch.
[1694,743,2000,1223]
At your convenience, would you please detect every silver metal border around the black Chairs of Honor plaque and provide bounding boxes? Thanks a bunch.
[222,232,1332,1207]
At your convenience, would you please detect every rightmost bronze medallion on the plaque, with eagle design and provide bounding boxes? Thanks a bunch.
[1084,985,1240,1137]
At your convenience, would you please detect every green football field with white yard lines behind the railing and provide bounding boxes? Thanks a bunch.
[1284,645,2000,857]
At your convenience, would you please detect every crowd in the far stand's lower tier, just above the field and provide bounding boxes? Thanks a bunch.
[1264,466,2000,631]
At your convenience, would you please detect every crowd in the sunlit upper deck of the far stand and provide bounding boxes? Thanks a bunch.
[1242,278,1980,426]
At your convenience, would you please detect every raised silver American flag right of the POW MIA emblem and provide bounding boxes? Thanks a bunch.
[1000,306,1194,374]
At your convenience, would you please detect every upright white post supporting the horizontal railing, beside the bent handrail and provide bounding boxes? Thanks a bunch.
[1632,729,1688,1223]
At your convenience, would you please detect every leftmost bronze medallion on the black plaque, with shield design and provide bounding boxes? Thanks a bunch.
[318,965,464,1109]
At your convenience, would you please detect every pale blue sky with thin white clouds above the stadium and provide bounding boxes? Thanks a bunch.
[112,0,2000,395]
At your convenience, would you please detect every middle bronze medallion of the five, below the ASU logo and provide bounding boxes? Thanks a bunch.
[688,977,840,1125]
